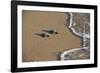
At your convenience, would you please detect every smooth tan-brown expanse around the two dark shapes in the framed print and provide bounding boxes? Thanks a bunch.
[22,10,80,62]
